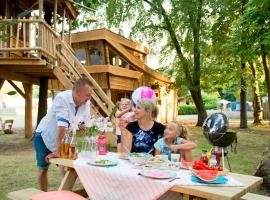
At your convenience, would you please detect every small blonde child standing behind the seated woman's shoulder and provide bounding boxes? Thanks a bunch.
[115,98,134,152]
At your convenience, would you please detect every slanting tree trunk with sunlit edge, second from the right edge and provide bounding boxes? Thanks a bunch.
[249,63,264,125]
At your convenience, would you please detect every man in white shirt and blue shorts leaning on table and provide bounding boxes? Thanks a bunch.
[33,78,93,191]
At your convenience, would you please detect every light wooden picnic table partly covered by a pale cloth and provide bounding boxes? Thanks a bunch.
[50,153,262,200]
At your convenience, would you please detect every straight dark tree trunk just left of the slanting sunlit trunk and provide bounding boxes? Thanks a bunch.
[240,63,248,128]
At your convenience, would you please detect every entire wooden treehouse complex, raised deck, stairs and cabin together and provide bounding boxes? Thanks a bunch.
[0,0,177,137]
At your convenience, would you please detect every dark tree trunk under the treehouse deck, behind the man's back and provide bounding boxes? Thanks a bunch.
[37,77,48,125]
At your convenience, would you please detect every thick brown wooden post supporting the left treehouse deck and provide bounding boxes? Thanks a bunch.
[23,83,33,138]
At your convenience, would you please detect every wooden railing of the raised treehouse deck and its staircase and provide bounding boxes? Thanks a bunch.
[0,18,114,116]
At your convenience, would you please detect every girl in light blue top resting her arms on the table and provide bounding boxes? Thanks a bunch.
[154,121,196,161]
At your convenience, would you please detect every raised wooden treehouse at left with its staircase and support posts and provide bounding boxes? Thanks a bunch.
[0,0,114,137]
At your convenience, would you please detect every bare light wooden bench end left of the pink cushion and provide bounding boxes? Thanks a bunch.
[7,188,43,200]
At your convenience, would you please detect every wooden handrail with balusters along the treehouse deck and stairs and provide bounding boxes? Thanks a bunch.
[0,18,114,115]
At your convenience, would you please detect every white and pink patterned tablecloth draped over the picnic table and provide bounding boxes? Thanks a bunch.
[74,153,243,200]
